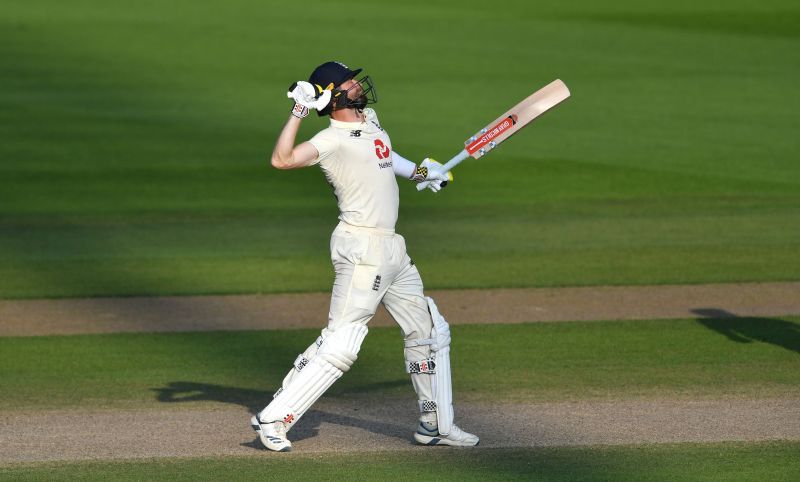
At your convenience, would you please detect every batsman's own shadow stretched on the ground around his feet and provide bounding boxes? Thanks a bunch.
[152,380,414,449]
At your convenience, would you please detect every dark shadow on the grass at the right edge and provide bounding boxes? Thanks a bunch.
[692,308,800,353]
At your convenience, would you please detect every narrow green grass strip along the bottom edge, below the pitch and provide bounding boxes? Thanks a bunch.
[0,442,800,481]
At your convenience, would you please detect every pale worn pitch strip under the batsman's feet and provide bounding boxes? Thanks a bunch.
[0,398,800,463]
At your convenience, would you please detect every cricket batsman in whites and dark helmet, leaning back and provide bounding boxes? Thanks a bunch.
[250,62,479,452]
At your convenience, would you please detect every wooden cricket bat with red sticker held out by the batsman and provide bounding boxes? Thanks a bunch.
[417,79,569,191]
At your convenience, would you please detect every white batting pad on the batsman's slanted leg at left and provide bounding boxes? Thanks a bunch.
[259,325,368,429]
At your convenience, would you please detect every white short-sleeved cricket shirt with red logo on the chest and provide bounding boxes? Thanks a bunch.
[309,109,400,230]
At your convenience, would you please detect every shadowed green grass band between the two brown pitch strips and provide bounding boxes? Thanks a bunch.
[0,317,800,410]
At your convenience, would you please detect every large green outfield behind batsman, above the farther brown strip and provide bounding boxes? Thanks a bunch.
[0,0,800,298]
